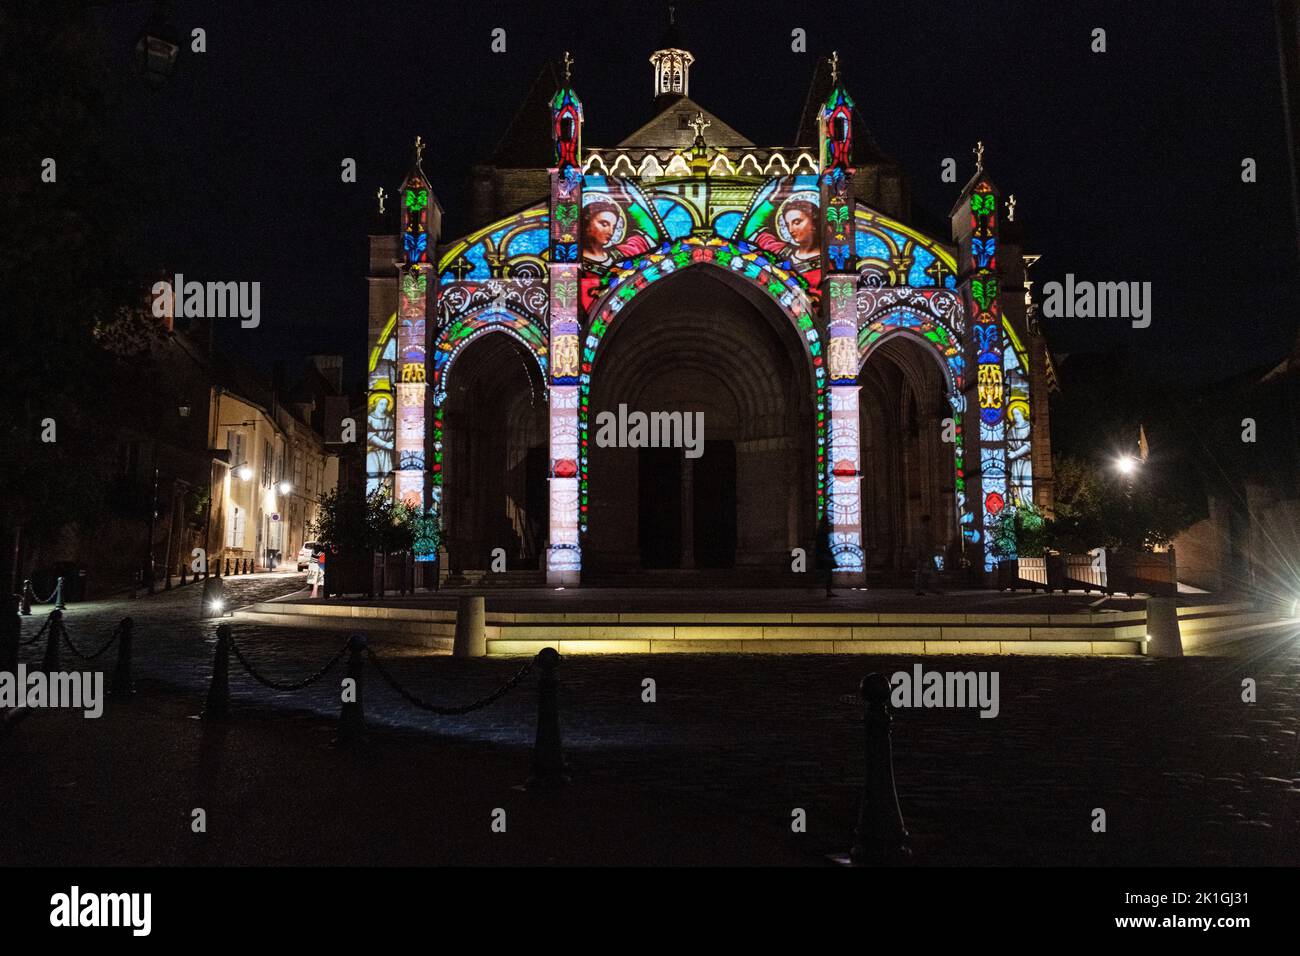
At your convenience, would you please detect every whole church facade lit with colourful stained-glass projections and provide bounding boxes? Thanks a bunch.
[367,35,1052,587]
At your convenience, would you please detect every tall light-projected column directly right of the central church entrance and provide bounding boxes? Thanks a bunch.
[820,61,865,583]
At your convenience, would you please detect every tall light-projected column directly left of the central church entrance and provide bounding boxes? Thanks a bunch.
[546,53,586,587]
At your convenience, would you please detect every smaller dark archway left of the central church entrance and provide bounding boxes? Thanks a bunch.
[437,332,549,572]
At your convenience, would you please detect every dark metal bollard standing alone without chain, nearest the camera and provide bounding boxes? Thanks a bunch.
[849,674,911,866]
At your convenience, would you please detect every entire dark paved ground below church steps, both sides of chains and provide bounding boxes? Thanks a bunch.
[0,575,1300,865]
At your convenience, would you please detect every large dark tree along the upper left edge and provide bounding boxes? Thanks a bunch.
[0,0,154,583]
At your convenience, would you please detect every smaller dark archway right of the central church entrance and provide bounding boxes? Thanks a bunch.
[858,334,959,583]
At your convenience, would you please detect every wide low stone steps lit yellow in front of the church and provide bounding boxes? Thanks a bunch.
[228,588,1291,656]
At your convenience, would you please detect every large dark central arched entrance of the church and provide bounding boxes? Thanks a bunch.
[584,265,816,581]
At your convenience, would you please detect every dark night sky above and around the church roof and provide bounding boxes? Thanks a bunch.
[91,0,1297,392]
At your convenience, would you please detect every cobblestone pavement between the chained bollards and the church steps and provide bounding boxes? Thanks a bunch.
[12,574,1300,865]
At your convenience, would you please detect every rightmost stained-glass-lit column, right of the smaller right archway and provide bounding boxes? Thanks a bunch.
[952,143,1008,572]
